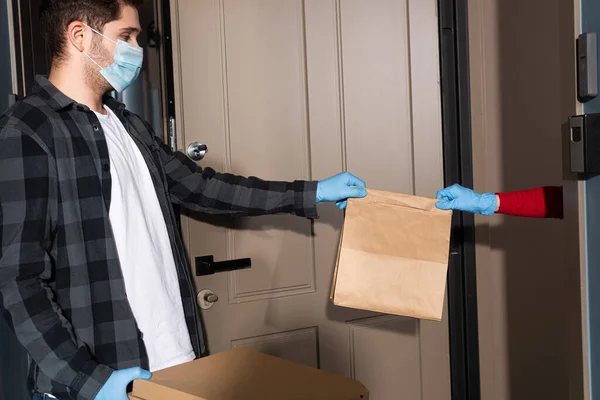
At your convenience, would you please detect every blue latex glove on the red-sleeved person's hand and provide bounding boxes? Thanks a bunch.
[435,185,498,215]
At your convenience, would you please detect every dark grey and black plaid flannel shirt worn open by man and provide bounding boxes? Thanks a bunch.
[0,77,316,400]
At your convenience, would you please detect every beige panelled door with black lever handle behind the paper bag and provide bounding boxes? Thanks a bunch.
[171,0,450,400]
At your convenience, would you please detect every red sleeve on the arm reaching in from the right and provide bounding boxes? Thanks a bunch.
[497,186,563,219]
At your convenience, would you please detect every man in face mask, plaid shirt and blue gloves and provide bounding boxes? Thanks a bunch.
[0,0,366,400]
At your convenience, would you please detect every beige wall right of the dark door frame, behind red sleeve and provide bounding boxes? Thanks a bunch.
[469,0,584,400]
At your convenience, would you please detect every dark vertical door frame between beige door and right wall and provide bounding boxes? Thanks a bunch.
[438,0,481,400]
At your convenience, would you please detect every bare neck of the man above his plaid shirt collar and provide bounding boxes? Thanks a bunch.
[49,68,104,113]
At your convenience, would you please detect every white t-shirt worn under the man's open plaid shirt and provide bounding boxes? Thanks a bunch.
[96,106,195,371]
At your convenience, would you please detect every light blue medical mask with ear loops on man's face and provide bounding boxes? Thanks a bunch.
[83,25,144,93]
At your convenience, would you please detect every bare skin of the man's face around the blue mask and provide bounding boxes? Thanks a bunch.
[84,6,141,93]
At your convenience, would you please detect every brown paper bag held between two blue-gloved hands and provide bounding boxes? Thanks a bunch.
[331,189,452,321]
